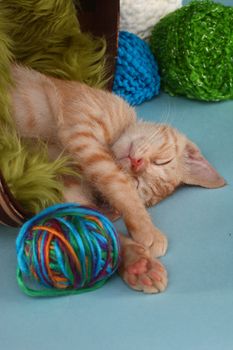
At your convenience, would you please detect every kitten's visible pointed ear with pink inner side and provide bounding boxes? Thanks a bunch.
[183,141,226,188]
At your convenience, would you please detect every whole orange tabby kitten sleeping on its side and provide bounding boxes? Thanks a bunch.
[11,66,225,293]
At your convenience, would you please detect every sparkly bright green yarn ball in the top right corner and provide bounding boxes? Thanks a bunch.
[150,0,233,101]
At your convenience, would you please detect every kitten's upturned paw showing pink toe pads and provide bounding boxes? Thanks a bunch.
[119,244,167,293]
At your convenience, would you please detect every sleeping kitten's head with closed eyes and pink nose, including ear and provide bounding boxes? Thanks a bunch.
[112,122,225,206]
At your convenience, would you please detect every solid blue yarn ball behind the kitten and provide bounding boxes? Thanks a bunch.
[113,32,160,106]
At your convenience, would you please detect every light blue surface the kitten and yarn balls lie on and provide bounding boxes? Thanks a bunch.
[0,1,233,350]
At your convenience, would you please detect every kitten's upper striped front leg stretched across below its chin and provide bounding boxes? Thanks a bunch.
[59,125,167,255]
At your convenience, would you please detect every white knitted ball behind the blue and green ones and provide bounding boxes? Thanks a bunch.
[120,0,182,39]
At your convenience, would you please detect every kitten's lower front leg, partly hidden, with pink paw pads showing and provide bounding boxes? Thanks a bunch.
[63,177,167,293]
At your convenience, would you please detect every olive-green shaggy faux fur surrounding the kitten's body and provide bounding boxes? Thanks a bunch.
[0,0,106,212]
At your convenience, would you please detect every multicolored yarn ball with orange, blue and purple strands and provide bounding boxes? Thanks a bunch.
[16,204,120,296]
